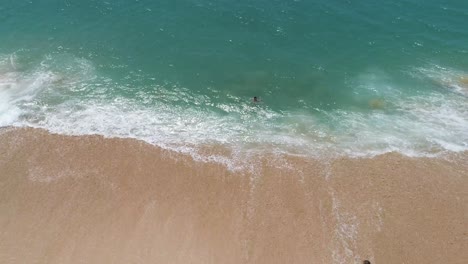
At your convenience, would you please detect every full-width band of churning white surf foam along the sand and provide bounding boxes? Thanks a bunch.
[0,56,468,165]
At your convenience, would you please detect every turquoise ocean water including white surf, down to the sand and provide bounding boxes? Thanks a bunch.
[0,0,468,157]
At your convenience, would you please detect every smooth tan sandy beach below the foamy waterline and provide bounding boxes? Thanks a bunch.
[0,128,468,263]
